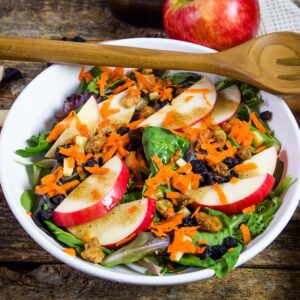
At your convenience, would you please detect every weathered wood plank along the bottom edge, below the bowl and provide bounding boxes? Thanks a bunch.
[0,265,300,300]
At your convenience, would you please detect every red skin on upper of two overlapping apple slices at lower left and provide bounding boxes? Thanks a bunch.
[53,159,129,227]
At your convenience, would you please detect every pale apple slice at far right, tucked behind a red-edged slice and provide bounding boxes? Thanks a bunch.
[239,146,277,178]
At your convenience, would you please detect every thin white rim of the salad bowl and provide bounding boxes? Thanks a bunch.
[0,38,300,285]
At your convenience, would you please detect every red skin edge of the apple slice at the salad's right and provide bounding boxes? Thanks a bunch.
[194,174,275,215]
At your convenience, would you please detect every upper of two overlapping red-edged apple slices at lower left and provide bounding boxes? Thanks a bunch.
[53,156,129,227]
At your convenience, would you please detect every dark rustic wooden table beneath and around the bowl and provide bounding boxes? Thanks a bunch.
[0,0,300,300]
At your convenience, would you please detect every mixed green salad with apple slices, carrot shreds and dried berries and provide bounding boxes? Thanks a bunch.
[16,67,292,278]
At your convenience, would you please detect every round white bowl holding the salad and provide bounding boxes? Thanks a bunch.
[0,38,300,285]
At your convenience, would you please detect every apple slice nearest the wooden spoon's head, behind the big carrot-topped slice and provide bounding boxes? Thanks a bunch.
[193,85,241,128]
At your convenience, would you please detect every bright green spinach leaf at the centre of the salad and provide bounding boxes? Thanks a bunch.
[142,126,189,175]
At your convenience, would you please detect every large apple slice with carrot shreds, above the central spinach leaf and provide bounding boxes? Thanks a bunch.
[140,77,217,130]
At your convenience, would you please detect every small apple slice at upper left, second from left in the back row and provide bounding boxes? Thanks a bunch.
[98,90,136,127]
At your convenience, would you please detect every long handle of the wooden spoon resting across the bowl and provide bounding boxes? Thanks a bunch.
[0,37,222,74]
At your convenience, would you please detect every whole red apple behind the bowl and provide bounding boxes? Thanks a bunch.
[163,0,260,50]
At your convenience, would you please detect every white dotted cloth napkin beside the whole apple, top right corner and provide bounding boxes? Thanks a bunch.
[258,0,300,35]
